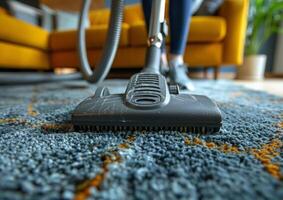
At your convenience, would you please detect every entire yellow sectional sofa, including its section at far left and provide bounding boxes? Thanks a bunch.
[0,0,249,79]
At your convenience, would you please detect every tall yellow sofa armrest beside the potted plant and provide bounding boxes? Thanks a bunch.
[219,0,249,65]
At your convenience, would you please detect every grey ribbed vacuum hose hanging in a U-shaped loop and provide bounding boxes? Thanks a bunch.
[77,0,124,83]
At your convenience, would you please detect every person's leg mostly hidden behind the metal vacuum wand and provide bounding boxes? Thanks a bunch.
[142,0,168,74]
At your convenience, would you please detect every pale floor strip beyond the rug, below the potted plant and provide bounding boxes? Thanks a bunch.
[235,78,283,97]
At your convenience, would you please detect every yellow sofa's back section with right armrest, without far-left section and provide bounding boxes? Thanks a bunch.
[50,0,248,79]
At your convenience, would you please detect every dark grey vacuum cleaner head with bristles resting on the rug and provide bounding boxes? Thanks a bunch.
[72,72,222,133]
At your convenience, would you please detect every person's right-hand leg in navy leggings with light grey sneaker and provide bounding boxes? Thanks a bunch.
[169,0,194,90]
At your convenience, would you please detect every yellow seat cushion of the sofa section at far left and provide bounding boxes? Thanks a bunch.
[0,15,49,50]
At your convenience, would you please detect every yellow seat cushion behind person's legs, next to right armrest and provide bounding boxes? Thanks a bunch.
[129,16,226,46]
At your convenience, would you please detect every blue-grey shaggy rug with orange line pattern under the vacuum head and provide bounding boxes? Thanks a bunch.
[0,80,283,200]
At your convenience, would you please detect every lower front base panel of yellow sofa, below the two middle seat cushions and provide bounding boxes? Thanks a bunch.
[50,42,222,68]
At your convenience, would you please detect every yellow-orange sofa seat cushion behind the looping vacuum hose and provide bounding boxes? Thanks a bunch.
[50,24,129,51]
